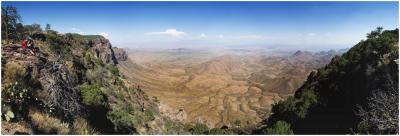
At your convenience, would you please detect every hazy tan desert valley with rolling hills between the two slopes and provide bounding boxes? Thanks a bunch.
[118,48,345,128]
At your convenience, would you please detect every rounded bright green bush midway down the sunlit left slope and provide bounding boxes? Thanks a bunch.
[80,84,107,106]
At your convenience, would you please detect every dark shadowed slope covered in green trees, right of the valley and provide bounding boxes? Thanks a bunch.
[263,28,399,134]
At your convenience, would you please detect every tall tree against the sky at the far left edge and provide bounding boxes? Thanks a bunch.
[1,6,22,44]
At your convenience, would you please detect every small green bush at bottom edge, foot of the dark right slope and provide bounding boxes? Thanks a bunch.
[264,121,293,135]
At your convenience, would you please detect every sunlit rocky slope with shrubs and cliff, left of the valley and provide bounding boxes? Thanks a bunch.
[2,31,194,134]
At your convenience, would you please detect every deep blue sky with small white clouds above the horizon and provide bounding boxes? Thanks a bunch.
[2,1,399,49]
